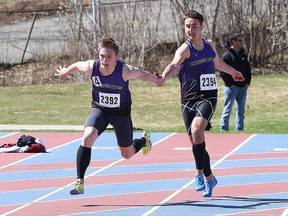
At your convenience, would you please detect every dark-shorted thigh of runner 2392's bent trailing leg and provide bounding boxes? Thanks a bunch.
[109,114,133,147]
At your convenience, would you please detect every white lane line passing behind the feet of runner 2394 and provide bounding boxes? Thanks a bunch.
[142,134,256,216]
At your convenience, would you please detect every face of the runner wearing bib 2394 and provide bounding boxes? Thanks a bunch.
[184,18,203,41]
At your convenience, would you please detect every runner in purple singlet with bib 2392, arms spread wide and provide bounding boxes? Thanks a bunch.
[55,38,163,195]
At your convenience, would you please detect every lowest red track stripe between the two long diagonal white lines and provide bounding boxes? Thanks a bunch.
[0,191,177,216]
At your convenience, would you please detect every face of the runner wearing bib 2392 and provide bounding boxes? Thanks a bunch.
[99,48,118,70]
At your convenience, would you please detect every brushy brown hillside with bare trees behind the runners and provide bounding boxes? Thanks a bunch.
[0,0,288,85]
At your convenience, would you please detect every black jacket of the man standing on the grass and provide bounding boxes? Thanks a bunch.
[220,48,251,87]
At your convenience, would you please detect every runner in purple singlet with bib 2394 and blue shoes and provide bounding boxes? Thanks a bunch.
[162,10,244,197]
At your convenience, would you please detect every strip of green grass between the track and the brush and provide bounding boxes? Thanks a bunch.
[0,75,288,133]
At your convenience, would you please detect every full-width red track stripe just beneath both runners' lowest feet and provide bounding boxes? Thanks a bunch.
[0,182,288,215]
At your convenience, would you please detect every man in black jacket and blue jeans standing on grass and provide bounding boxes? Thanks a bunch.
[220,33,251,131]
